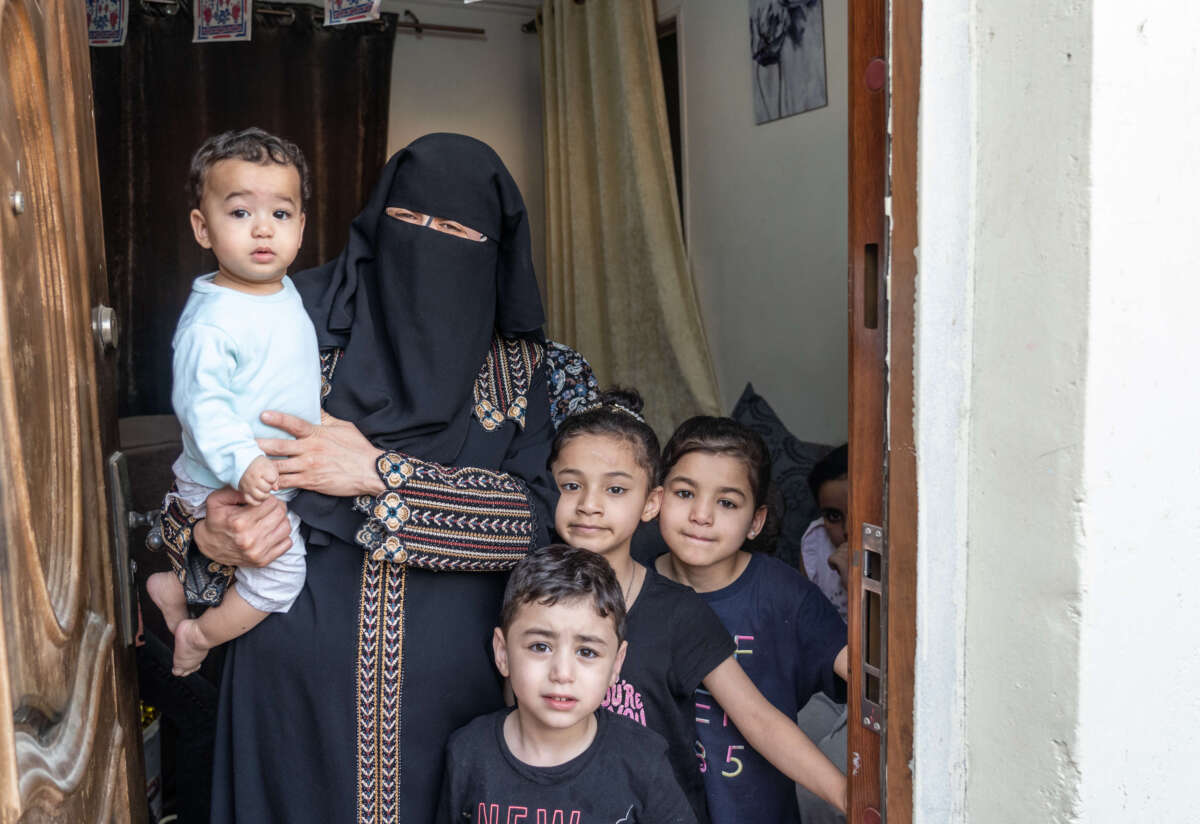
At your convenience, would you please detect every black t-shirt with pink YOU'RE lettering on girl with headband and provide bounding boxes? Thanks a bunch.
[602,567,733,822]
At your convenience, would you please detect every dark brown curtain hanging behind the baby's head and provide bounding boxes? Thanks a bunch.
[91,2,396,416]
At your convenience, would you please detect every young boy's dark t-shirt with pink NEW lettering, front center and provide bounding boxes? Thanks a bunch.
[437,709,696,824]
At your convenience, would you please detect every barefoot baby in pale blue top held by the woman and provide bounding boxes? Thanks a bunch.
[146,128,320,675]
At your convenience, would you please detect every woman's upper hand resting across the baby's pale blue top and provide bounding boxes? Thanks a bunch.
[258,411,384,498]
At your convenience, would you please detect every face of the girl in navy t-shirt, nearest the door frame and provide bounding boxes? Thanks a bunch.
[659,452,767,569]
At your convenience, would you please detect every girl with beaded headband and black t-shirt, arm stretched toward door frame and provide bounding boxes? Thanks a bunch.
[550,391,846,822]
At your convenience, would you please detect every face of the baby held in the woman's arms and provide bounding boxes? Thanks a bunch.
[191,160,305,295]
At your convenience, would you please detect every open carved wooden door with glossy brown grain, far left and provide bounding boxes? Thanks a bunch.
[0,0,146,824]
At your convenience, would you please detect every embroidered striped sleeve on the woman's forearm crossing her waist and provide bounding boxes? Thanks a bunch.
[354,452,535,571]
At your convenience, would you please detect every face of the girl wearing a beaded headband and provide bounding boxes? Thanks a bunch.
[551,434,662,563]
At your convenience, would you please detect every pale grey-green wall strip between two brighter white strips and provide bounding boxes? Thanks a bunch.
[965,0,1091,823]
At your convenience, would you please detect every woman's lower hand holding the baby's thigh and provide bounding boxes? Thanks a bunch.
[192,487,292,566]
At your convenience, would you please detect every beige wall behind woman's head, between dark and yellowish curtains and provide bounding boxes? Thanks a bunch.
[383,0,546,284]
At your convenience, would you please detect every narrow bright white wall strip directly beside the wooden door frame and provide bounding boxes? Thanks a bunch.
[913,0,974,824]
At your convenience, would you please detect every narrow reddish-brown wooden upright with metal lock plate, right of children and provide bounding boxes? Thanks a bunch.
[846,0,888,824]
